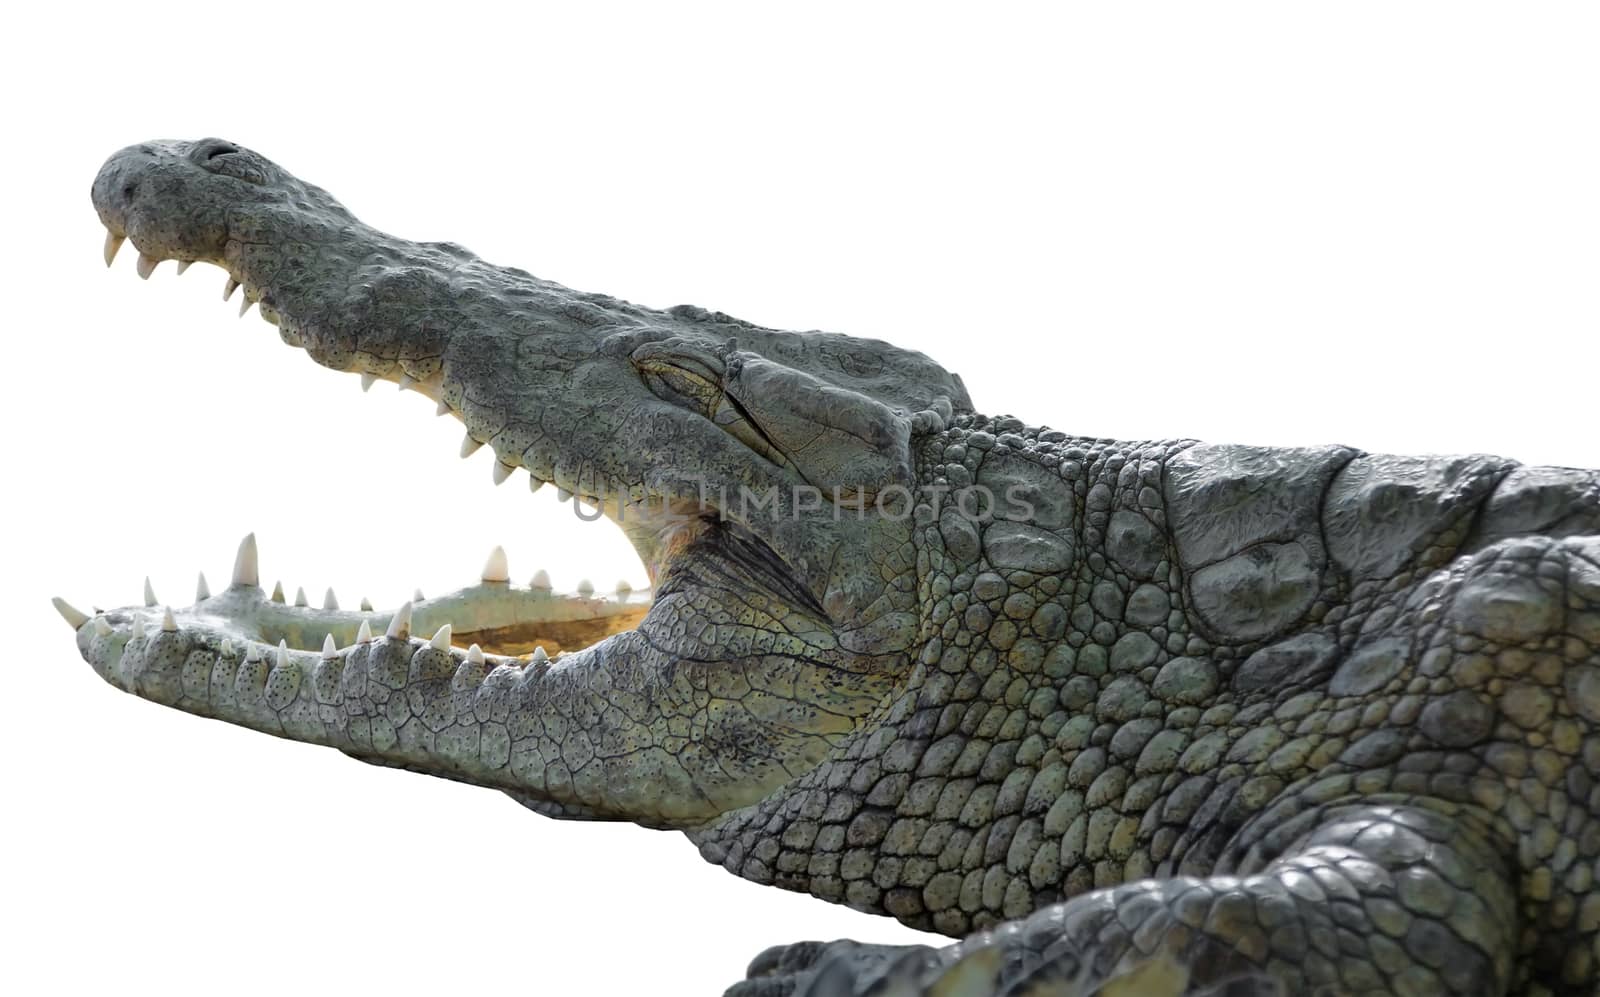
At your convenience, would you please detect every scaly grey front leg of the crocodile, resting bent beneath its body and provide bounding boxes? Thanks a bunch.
[728,800,1517,997]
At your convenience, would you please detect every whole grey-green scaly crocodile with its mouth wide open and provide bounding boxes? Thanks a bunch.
[56,139,1600,997]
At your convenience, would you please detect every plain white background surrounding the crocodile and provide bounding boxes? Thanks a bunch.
[0,0,1600,995]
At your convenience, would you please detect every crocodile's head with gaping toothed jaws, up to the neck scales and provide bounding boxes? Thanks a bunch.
[64,139,971,826]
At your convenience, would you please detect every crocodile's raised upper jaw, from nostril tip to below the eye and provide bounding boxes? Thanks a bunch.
[94,139,928,630]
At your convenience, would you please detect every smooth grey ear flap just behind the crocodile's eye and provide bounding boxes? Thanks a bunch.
[715,354,912,503]
